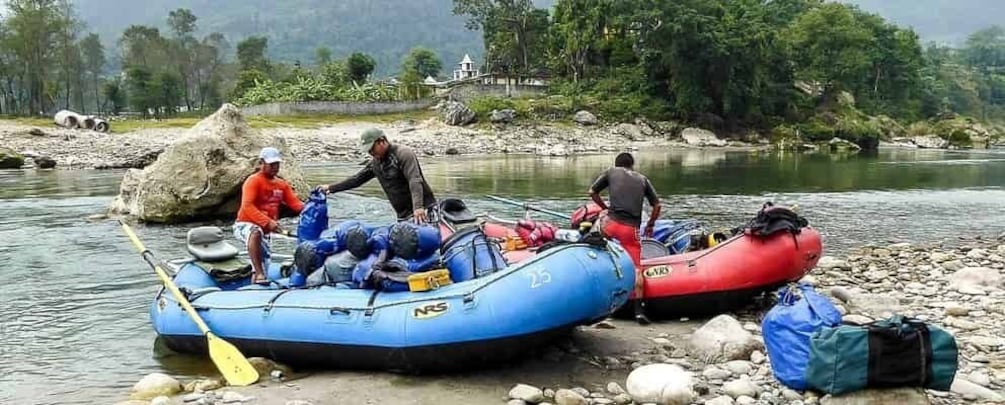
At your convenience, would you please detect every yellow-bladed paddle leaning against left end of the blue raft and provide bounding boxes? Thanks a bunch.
[119,220,258,387]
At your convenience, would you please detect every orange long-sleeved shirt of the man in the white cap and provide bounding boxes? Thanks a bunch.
[237,171,304,230]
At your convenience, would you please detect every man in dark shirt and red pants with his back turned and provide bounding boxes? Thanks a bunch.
[590,153,660,325]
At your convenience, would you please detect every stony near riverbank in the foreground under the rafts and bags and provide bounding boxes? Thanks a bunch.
[119,239,1005,405]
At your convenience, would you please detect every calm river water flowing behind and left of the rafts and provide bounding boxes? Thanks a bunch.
[0,150,1005,404]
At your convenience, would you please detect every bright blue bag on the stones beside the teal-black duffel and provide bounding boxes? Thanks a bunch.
[761,282,841,391]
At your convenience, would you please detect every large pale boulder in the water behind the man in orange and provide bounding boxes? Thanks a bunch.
[110,104,310,223]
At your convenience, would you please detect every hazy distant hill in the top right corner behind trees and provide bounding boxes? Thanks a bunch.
[842,0,1005,45]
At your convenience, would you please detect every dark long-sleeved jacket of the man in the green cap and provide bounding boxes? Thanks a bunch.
[329,145,436,219]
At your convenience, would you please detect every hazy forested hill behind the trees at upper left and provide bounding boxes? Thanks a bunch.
[75,0,482,74]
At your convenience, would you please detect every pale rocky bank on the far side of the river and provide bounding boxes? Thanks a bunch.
[0,113,751,169]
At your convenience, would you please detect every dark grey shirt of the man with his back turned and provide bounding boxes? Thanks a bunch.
[590,167,659,227]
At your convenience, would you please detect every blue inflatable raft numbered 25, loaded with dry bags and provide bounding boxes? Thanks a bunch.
[150,225,635,373]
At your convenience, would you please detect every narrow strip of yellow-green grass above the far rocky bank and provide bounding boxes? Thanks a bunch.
[0,110,436,134]
